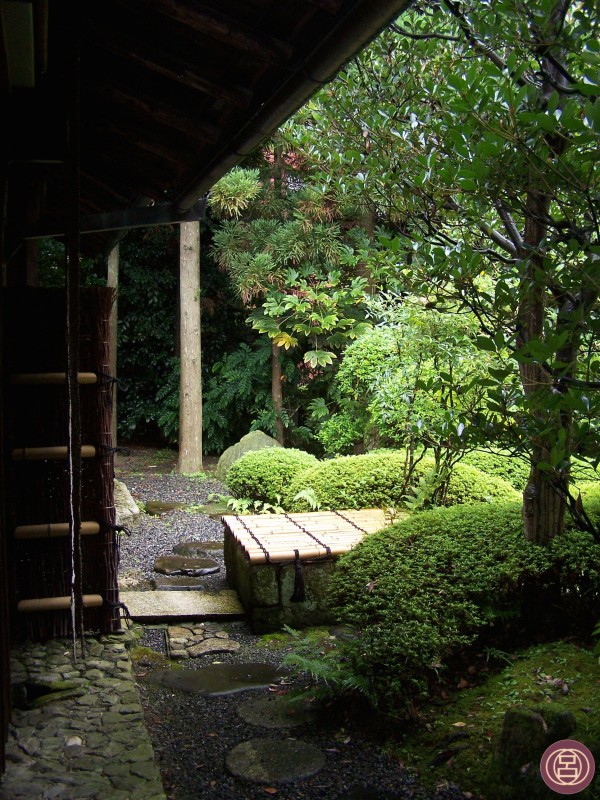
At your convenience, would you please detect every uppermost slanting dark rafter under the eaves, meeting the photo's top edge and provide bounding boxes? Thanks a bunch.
[152,0,293,66]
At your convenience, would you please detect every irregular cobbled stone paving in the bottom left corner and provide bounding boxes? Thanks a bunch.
[0,631,166,800]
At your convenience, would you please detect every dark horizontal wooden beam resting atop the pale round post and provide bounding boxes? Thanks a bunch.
[23,198,207,240]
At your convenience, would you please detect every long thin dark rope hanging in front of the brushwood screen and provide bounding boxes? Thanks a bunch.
[65,11,85,659]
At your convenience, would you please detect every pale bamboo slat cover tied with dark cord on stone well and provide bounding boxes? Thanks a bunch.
[223,508,387,564]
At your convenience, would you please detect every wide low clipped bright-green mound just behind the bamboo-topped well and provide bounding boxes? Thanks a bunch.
[284,451,516,511]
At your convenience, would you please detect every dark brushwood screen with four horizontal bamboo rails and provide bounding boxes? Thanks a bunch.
[3,288,120,639]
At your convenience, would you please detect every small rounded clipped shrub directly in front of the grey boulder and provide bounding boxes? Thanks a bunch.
[227,447,319,505]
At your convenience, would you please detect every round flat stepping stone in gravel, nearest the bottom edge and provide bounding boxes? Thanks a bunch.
[225,739,325,783]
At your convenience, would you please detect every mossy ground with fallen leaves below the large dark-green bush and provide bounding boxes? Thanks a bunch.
[389,642,600,800]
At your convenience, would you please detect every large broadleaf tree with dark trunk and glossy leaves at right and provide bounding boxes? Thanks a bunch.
[285,0,600,544]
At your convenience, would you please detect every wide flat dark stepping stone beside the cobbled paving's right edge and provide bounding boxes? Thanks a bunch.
[146,663,289,697]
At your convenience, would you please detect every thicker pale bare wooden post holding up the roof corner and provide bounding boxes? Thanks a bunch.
[178,222,202,473]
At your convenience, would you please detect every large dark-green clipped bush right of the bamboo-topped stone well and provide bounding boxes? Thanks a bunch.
[330,494,600,713]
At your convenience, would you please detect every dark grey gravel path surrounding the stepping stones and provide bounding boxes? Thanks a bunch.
[120,456,470,800]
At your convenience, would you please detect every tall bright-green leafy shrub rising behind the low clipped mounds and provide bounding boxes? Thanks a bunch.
[319,304,491,460]
